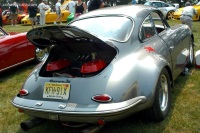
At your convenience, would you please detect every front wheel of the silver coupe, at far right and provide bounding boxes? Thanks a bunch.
[187,39,195,67]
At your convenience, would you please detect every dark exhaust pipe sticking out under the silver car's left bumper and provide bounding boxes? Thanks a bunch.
[20,118,46,131]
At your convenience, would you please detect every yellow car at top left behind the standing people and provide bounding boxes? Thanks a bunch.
[21,0,70,25]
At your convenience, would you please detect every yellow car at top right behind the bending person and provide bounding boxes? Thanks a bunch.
[173,2,200,21]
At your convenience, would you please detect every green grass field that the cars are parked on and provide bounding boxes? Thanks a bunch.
[0,21,200,133]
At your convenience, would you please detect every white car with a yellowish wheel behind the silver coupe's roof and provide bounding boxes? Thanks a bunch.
[144,1,176,19]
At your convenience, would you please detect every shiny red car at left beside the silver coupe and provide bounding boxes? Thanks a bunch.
[0,28,48,73]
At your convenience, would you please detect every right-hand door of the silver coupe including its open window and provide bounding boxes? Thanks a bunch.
[151,13,189,77]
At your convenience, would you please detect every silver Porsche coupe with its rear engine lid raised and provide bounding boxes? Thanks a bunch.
[12,5,194,130]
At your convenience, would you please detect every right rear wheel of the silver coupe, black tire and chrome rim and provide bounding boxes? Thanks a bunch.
[147,68,171,122]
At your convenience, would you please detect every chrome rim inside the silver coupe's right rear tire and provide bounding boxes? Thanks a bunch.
[159,75,168,111]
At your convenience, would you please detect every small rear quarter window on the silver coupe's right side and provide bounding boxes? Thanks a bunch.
[139,15,156,41]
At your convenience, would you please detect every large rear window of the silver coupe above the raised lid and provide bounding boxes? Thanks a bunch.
[70,16,133,42]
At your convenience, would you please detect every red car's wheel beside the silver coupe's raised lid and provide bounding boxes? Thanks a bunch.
[34,48,49,63]
